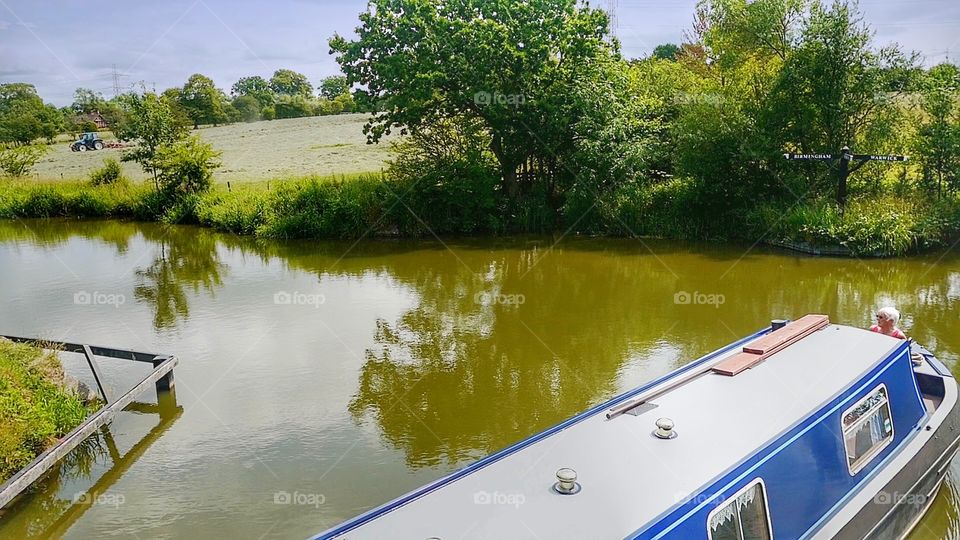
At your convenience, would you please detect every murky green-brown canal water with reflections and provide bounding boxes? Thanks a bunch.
[0,220,960,539]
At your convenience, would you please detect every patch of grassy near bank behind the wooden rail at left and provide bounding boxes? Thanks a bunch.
[0,339,95,482]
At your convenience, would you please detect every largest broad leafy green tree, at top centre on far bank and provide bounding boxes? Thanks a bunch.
[330,0,615,198]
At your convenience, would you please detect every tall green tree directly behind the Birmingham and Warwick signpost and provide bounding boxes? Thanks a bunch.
[764,1,915,206]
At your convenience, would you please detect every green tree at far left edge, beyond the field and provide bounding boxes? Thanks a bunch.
[0,83,63,144]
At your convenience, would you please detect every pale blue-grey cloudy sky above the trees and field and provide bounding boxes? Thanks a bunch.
[0,0,960,106]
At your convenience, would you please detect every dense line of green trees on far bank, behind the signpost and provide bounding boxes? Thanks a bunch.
[330,0,960,245]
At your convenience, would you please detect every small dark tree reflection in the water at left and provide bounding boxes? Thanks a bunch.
[133,228,226,330]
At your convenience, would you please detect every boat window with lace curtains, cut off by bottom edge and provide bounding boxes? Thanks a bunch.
[707,478,771,540]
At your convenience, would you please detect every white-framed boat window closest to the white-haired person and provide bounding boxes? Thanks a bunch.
[842,384,893,474]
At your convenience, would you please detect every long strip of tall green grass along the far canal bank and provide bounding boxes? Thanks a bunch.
[0,174,960,256]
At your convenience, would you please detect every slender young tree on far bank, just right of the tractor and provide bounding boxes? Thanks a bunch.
[114,92,188,186]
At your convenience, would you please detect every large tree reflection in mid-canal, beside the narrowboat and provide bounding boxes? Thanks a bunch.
[349,250,684,467]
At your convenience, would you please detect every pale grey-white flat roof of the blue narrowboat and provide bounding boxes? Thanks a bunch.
[326,325,902,540]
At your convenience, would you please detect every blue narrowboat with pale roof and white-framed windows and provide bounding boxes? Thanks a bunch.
[315,315,960,540]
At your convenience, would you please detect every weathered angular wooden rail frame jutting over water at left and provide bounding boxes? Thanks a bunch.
[0,335,179,508]
